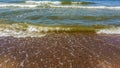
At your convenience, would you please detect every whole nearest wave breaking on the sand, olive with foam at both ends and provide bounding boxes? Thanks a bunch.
[0,23,120,38]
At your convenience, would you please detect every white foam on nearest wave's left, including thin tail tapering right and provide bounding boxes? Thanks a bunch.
[0,24,71,38]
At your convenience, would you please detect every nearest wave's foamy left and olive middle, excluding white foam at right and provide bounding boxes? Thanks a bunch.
[0,23,104,37]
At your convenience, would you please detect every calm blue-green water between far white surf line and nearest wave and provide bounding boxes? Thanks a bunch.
[0,8,120,25]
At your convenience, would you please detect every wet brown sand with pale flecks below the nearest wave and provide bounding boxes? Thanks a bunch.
[0,33,120,68]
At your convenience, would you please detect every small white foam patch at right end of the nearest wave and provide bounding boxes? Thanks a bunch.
[97,27,120,34]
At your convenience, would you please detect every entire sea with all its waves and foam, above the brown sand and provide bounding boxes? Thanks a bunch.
[0,0,120,37]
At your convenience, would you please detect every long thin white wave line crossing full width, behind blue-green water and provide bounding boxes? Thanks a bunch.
[0,4,120,10]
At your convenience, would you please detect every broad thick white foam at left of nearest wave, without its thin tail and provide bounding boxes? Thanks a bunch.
[0,24,46,38]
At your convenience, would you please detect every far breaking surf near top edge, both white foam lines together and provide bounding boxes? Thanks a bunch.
[0,1,120,9]
